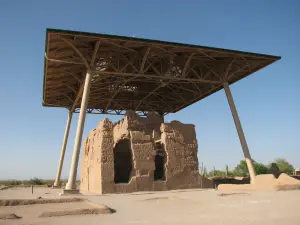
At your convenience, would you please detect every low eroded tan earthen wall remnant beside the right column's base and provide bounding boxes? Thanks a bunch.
[218,173,300,191]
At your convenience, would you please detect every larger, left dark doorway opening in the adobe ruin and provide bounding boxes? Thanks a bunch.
[114,139,132,183]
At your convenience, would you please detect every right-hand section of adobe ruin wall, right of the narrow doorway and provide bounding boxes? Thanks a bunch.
[161,121,201,190]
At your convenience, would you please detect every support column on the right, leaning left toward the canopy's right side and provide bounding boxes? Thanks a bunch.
[223,83,255,183]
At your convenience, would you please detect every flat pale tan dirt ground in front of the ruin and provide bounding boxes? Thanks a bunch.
[0,188,300,225]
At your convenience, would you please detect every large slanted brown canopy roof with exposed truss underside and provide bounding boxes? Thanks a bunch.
[43,29,280,114]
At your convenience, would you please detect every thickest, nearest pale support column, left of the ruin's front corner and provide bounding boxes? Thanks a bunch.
[64,71,91,193]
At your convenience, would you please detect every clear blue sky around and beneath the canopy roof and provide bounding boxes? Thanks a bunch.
[0,0,300,179]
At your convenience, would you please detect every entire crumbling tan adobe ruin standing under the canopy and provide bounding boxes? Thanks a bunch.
[80,111,213,194]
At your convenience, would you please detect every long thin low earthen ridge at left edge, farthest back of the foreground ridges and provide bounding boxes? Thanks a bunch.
[0,198,84,206]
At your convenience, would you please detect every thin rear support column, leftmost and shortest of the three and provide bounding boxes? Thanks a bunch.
[53,111,73,188]
